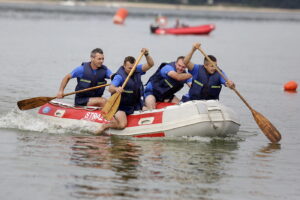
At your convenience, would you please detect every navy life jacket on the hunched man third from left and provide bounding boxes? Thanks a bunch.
[148,62,185,101]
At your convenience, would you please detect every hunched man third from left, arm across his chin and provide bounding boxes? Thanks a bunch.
[144,56,192,110]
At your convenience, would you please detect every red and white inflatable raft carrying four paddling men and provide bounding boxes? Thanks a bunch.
[38,100,240,137]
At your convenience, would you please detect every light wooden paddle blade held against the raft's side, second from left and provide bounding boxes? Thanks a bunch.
[101,92,121,120]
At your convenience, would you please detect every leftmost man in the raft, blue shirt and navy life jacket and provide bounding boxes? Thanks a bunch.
[57,48,112,107]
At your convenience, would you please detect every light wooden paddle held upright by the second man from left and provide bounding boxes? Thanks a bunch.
[101,53,144,120]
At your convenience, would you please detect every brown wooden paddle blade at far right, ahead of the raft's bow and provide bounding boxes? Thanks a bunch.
[252,110,281,143]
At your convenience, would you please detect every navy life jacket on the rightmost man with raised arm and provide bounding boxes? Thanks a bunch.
[189,65,222,100]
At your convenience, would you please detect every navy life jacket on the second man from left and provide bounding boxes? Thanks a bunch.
[111,66,144,110]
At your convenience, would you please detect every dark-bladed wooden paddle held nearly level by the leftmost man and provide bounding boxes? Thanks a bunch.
[17,84,109,110]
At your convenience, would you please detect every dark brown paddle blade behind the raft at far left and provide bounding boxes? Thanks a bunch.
[17,97,56,110]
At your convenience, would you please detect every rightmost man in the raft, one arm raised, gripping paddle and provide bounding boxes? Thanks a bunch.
[182,43,235,102]
